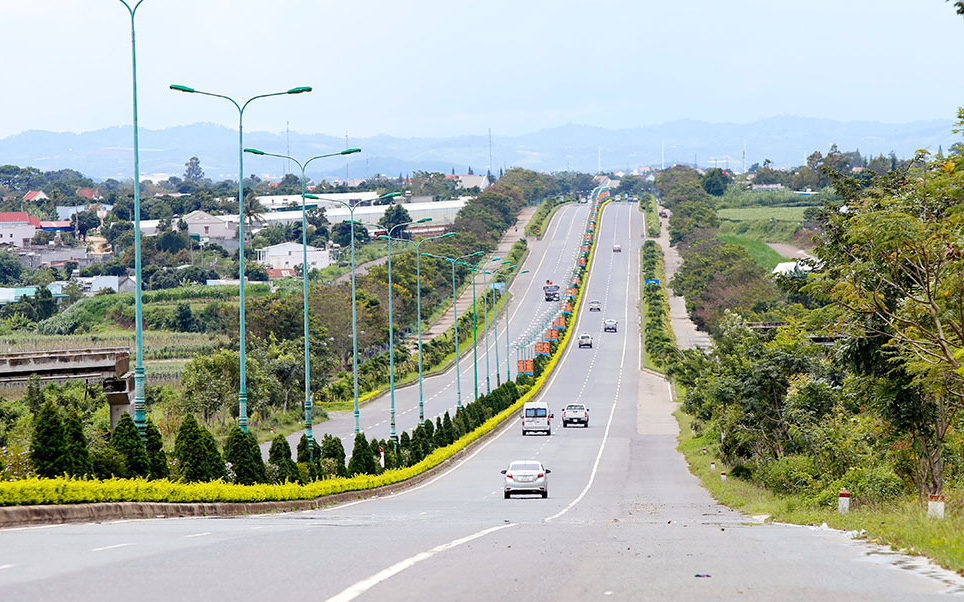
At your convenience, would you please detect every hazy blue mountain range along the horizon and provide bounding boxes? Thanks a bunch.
[0,116,960,181]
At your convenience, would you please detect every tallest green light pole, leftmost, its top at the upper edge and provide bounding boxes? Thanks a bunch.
[120,0,147,442]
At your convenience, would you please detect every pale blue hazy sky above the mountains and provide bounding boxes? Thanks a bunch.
[0,0,964,137]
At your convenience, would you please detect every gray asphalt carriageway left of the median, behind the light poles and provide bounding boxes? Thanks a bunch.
[261,205,588,458]
